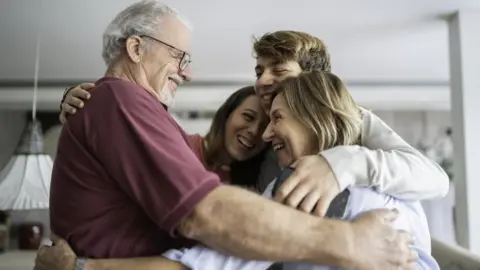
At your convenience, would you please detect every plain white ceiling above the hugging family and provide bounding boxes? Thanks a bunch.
[0,0,480,84]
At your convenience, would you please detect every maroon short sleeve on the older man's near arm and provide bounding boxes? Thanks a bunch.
[89,83,220,233]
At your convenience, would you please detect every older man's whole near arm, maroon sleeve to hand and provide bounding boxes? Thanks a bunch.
[88,83,411,269]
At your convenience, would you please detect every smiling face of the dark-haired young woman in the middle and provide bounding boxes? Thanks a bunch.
[225,95,268,161]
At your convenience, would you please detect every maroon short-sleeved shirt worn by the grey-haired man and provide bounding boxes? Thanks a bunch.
[50,78,220,258]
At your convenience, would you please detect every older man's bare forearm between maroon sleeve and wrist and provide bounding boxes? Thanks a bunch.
[178,186,350,265]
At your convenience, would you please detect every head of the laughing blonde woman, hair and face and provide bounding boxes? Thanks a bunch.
[264,71,362,166]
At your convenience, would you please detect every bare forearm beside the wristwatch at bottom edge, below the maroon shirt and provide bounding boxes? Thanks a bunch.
[85,256,189,270]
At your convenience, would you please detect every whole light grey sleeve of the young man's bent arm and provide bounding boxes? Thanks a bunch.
[320,110,449,200]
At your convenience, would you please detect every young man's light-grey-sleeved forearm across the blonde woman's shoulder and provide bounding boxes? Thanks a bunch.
[321,145,448,200]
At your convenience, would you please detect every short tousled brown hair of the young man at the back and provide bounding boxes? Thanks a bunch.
[253,31,332,72]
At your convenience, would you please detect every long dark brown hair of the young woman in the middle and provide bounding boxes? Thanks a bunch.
[205,86,267,188]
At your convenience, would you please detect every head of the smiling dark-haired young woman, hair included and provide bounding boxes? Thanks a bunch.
[201,86,267,187]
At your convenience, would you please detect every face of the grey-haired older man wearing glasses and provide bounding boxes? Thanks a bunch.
[137,16,190,106]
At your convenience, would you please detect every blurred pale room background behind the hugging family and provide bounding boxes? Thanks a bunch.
[0,0,480,268]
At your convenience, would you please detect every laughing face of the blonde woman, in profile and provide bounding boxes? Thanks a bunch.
[263,94,318,167]
